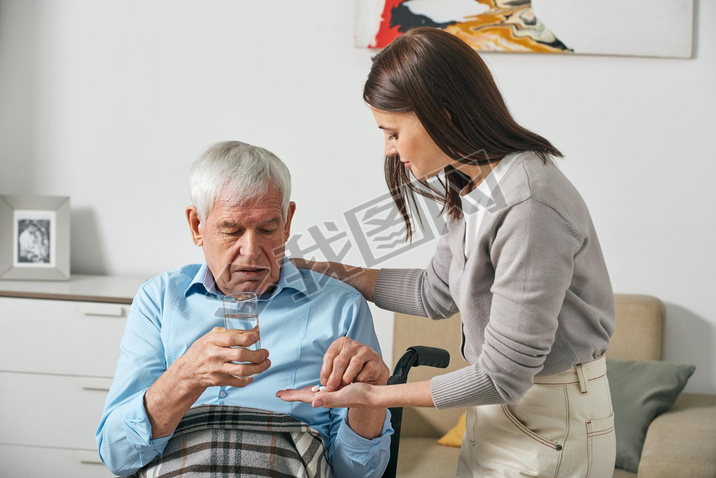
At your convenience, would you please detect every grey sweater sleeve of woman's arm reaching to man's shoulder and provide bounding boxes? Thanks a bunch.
[373,229,457,319]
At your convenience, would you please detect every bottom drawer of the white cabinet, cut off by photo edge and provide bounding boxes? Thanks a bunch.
[0,445,114,478]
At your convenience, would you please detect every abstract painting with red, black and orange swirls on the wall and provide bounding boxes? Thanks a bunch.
[355,0,693,58]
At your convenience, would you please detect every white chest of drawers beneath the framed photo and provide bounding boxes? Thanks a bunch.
[0,276,143,478]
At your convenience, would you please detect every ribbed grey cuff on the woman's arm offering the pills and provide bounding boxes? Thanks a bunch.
[430,366,505,409]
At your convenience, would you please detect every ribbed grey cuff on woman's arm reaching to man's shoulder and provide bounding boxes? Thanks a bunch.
[373,269,427,317]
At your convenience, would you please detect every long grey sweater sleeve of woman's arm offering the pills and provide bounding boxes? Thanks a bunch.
[431,199,583,408]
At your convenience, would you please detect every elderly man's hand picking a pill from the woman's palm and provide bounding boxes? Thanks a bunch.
[321,337,390,391]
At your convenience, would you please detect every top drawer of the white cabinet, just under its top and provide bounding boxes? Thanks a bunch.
[0,297,129,377]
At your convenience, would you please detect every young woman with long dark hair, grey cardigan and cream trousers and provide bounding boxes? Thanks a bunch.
[279,28,615,477]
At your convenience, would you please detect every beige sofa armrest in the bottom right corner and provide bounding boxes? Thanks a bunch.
[639,393,716,478]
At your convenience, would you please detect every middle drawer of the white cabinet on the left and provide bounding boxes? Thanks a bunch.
[0,372,111,452]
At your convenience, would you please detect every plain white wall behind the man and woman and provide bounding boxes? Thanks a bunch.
[0,0,716,393]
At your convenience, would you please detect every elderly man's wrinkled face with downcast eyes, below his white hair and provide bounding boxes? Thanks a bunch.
[187,185,296,295]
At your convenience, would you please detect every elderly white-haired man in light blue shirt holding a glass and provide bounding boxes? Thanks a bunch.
[97,142,392,477]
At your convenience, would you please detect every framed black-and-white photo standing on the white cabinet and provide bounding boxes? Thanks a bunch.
[0,195,70,280]
